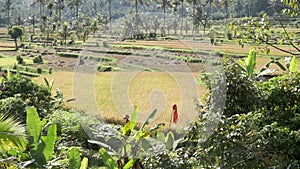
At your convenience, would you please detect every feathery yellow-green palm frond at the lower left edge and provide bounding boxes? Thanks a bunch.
[0,114,26,151]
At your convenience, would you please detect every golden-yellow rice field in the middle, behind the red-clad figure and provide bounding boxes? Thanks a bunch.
[35,72,207,127]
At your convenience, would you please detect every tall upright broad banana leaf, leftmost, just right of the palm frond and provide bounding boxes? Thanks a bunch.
[26,107,42,151]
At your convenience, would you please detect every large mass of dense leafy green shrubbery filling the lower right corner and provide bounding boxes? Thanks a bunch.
[181,62,300,168]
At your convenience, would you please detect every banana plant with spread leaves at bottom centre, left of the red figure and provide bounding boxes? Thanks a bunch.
[89,106,168,169]
